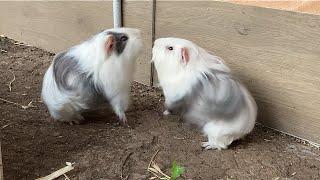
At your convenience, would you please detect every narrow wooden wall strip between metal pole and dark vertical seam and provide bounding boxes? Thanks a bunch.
[123,1,152,85]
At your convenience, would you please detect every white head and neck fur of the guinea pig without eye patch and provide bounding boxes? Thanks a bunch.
[152,38,230,103]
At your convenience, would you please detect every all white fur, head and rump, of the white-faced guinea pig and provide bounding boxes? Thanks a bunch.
[152,38,257,149]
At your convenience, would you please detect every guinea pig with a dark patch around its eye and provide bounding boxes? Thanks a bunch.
[41,28,142,125]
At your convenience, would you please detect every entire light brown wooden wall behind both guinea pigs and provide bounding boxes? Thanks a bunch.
[0,0,320,143]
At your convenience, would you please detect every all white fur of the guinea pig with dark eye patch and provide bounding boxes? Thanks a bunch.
[42,28,142,124]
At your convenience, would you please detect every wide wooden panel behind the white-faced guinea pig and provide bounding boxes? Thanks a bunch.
[156,1,320,143]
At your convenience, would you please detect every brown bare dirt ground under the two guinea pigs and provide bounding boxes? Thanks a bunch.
[0,38,320,180]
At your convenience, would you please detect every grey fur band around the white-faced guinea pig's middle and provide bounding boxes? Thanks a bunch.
[167,70,246,125]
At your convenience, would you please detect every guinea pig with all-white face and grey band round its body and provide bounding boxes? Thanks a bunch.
[152,38,257,150]
